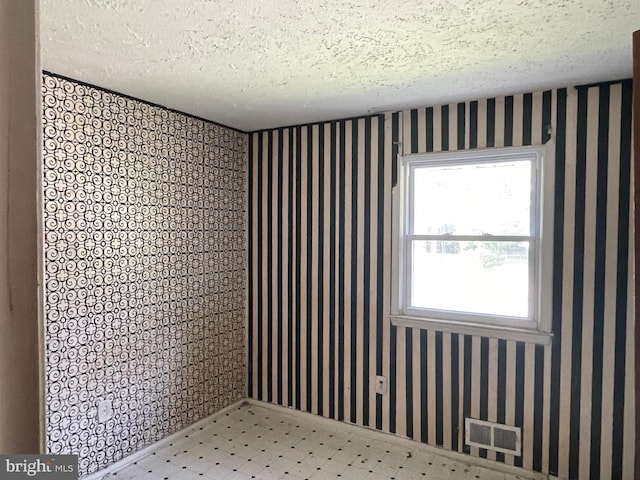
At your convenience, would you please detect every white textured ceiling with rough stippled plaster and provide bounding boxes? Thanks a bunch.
[40,0,640,130]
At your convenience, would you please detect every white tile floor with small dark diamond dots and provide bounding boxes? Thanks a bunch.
[104,404,519,480]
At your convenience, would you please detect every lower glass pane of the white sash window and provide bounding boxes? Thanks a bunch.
[409,240,529,318]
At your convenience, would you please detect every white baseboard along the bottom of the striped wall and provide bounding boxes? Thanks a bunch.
[246,399,557,480]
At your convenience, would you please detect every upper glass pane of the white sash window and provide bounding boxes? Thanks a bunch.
[411,160,532,236]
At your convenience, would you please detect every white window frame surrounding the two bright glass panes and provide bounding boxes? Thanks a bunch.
[391,142,554,344]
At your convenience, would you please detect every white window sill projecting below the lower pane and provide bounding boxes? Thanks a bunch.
[390,315,553,345]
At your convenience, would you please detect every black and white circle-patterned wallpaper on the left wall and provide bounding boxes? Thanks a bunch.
[43,74,247,475]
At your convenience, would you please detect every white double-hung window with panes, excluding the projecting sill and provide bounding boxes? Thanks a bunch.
[395,147,549,340]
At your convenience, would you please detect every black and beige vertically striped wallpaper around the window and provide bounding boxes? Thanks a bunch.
[248,81,634,479]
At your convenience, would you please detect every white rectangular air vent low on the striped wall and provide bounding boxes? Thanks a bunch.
[464,418,522,457]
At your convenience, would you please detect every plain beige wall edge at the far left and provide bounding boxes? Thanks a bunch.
[0,0,42,454]
